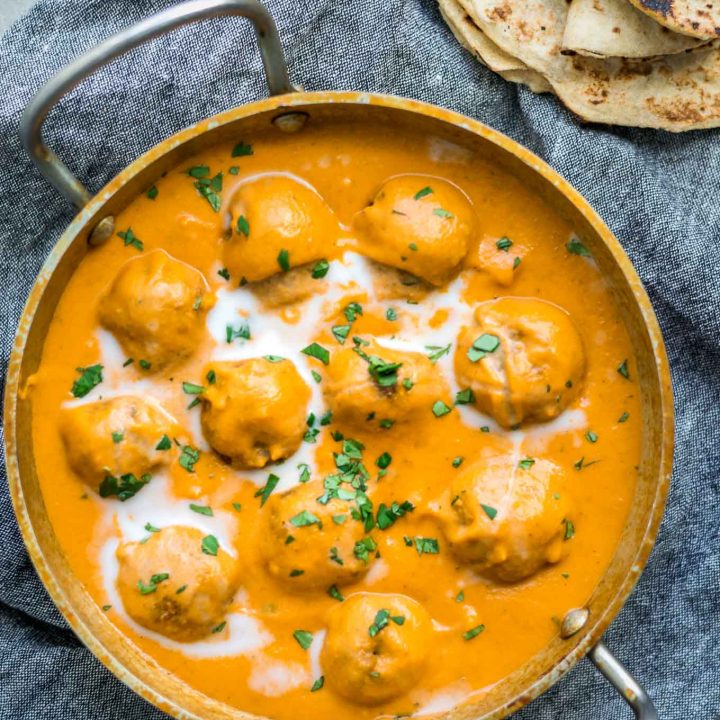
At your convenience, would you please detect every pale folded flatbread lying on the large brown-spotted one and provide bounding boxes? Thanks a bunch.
[562,0,707,58]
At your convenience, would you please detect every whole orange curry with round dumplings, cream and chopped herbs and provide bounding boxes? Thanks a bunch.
[29,123,641,719]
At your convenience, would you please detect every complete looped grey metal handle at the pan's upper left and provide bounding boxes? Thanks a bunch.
[20,0,295,209]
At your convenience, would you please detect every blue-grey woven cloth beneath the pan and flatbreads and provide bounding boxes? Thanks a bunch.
[0,0,720,720]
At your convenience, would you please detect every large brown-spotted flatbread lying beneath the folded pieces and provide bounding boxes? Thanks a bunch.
[458,0,720,132]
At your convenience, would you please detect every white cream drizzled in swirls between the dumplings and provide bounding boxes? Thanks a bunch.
[80,250,587,696]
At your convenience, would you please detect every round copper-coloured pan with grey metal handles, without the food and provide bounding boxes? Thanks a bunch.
[5,0,673,720]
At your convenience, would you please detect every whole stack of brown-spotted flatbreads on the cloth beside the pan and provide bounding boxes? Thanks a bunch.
[439,0,720,132]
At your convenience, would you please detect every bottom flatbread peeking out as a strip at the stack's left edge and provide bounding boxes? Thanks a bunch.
[439,0,552,93]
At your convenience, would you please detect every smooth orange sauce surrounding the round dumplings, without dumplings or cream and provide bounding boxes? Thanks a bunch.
[29,124,641,720]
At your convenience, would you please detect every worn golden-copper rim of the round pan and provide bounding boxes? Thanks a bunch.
[4,91,674,720]
